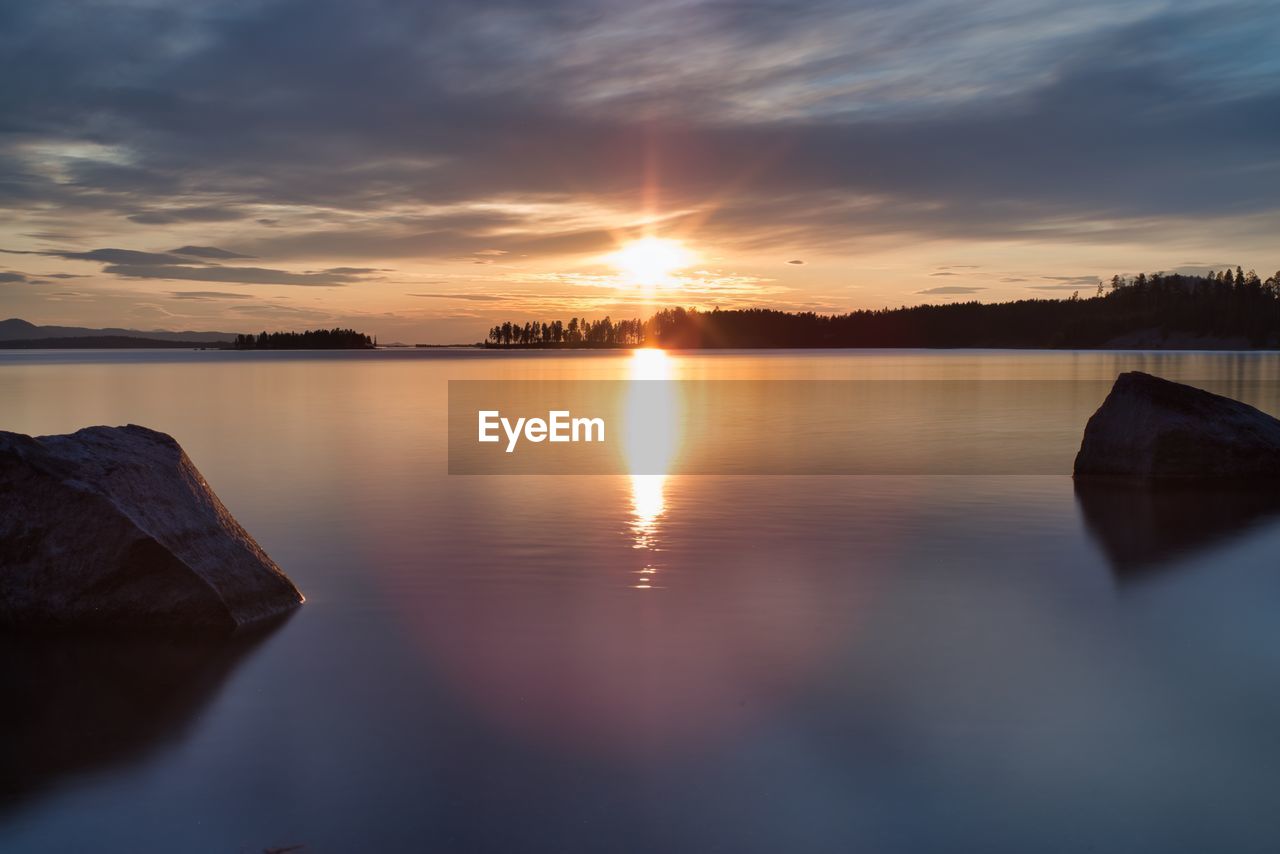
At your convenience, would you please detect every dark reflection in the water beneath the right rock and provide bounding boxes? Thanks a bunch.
[1075,480,1280,581]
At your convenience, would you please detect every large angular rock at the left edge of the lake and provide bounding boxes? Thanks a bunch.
[0,424,302,631]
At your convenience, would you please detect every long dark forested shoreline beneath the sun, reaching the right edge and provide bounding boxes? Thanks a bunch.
[486,268,1280,350]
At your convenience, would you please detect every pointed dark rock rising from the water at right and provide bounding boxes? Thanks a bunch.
[1075,371,1280,480]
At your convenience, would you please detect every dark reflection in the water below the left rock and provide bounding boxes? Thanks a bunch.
[0,622,282,814]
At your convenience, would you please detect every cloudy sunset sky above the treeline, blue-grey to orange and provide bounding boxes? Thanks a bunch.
[0,0,1280,343]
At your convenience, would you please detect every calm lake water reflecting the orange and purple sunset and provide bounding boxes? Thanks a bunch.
[0,352,1280,854]
